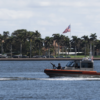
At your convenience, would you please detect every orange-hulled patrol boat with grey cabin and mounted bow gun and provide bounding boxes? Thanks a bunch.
[44,57,100,78]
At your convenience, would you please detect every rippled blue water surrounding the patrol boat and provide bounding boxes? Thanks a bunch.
[0,60,100,100]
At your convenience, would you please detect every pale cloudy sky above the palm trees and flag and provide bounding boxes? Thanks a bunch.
[0,0,100,39]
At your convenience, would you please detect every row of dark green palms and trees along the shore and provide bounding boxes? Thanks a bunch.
[0,29,100,57]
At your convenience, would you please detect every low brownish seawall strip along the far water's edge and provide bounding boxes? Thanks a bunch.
[0,58,100,61]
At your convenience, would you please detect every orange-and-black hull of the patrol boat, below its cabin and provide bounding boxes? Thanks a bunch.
[44,69,100,77]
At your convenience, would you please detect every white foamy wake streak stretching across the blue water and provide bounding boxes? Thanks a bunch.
[0,77,100,81]
